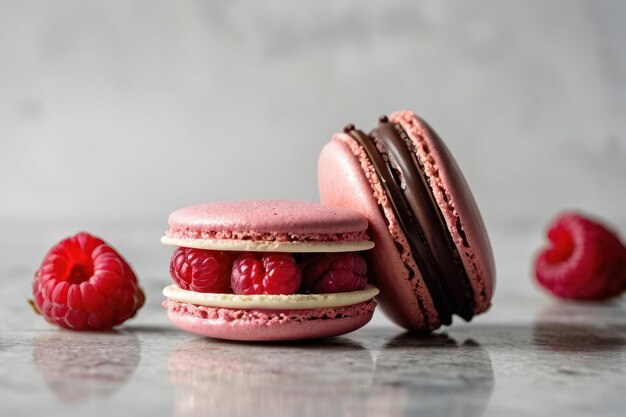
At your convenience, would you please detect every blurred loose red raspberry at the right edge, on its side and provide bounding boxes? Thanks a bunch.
[535,213,626,300]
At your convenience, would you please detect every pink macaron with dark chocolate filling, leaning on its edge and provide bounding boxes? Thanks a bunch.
[318,111,495,332]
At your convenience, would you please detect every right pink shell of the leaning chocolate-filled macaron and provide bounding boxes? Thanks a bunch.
[390,110,495,314]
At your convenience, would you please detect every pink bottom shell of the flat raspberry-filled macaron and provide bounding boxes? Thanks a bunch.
[163,300,376,342]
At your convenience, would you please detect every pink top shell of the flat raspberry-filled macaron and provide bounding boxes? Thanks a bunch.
[166,200,369,243]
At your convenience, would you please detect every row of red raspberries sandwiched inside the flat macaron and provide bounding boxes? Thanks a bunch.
[170,248,367,295]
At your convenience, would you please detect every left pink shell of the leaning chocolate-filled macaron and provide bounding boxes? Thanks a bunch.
[318,133,439,330]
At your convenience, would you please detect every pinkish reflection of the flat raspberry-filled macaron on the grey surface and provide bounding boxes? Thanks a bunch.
[169,337,374,417]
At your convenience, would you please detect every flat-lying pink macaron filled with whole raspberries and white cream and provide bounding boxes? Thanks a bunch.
[161,200,378,341]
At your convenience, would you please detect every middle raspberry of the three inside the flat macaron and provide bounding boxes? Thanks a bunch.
[230,252,302,295]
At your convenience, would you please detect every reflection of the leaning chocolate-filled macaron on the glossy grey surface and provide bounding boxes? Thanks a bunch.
[367,333,494,417]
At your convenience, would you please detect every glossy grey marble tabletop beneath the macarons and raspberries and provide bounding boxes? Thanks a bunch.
[0,222,626,417]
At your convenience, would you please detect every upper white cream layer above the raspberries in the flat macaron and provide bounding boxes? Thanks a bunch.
[161,236,374,253]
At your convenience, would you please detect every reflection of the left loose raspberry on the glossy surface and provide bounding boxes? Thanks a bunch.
[33,332,141,403]
